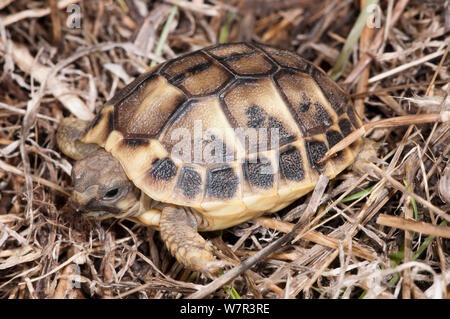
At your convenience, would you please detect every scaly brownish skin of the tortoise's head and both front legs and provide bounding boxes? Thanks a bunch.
[56,118,221,275]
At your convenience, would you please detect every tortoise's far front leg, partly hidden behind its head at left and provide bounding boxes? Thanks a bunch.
[56,117,99,160]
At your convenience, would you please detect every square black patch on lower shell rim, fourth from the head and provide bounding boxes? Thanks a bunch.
[242,156,273,189]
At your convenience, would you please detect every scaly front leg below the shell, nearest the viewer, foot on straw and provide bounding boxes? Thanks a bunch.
[159,206,220,275]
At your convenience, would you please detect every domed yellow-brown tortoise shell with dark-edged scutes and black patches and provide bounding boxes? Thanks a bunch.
[82,43,362,230]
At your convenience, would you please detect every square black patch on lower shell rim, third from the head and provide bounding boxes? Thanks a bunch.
[206,165,239,199]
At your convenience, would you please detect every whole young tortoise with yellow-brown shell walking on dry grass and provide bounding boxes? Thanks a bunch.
[57,43,363,274]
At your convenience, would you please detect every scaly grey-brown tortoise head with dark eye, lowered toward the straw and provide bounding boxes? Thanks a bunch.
[71,149,139,219]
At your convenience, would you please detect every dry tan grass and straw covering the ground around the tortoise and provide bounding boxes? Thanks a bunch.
[0,0,450,298]
